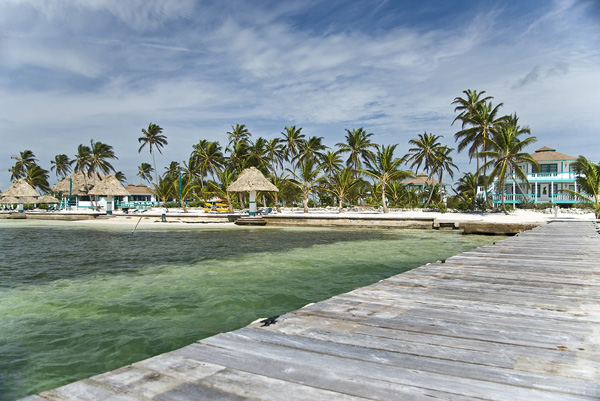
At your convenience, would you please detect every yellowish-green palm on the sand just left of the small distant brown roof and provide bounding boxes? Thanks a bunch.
[360,145,413,213]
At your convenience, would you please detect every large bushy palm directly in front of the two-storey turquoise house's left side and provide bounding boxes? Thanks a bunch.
[481,116,539,214]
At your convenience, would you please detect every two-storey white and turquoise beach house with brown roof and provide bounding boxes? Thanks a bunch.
[490,146,579,205]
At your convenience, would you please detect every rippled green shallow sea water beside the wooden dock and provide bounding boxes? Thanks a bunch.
[0,220,493,401]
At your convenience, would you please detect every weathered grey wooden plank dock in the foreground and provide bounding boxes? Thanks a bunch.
[25,222,600,401]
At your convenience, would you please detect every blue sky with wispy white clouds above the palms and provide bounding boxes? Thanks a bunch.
[0,0,600,190]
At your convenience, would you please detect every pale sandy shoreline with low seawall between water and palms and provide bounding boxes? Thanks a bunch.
[0,209,596,235]
